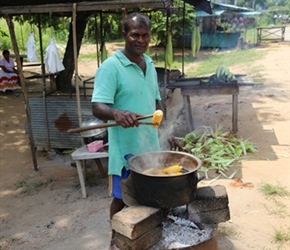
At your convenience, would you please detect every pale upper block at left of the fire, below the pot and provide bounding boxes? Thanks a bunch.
[112,206,162,240]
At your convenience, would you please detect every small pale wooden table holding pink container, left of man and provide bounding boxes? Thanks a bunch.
[71,145,109,198]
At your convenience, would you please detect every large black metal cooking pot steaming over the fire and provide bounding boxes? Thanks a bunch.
[128,151,201,208]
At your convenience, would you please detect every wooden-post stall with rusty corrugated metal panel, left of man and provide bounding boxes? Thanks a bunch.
[0,0,171,169]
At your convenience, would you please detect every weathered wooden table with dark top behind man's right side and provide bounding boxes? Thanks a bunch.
[169,77,239,134]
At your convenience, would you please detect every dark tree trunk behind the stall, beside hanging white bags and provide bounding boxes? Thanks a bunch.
[56,13,90,93]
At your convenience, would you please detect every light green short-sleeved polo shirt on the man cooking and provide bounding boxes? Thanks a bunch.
[92,50,161,175]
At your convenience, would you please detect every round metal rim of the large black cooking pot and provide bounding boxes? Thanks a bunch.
[128,150,202,178]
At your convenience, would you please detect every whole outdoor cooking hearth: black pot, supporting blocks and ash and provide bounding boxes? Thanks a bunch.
[112,151,230,250]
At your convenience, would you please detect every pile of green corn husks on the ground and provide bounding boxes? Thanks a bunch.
[176,127,257,177]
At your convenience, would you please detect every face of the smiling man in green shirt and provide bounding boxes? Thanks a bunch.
[124,19,150,56]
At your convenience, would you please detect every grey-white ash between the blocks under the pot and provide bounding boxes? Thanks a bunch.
[149,206,215,250]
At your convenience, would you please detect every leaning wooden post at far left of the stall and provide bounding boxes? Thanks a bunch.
[5,15,38,171]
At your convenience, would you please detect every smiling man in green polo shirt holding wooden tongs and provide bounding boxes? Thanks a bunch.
[92,13,161,249]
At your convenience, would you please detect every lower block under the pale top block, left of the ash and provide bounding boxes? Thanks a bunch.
[115,225,162,250]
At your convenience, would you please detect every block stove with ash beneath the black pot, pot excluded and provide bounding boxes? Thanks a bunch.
[112,181,230,250]
